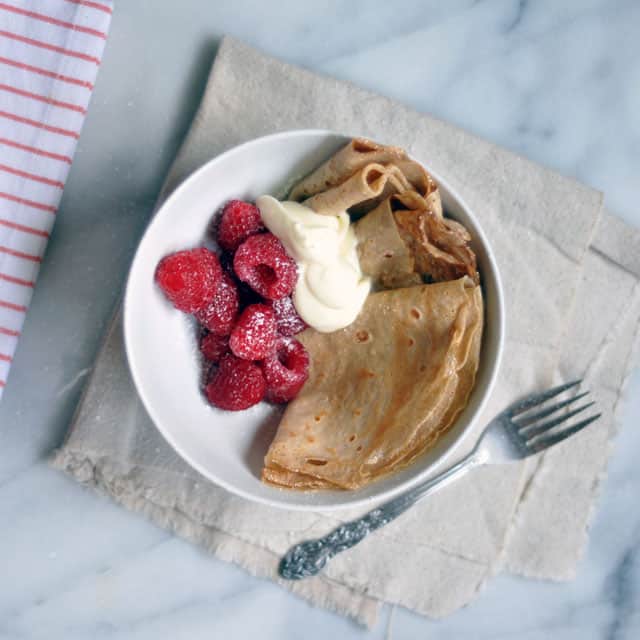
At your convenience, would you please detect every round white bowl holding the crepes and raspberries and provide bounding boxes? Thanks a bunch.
[124,130,504,510]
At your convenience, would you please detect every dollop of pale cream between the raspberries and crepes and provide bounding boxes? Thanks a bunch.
[256,196,371,333]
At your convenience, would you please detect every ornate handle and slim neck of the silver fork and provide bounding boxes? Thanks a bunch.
[278,453,474,580]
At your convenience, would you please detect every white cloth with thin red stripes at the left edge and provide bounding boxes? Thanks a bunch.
[0,0,113,397]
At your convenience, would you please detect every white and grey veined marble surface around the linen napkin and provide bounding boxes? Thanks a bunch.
[0,0,640,640]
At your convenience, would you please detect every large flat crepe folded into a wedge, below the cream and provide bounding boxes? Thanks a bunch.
[262,277,483,489]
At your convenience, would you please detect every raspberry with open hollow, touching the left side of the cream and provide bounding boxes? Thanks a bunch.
[233,233,298,300]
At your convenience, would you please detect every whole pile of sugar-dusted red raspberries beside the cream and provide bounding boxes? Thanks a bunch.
[155,200,309,411]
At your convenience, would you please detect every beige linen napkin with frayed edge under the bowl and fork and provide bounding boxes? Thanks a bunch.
[54,38,640,625]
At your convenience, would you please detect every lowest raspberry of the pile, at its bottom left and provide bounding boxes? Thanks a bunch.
[205,354,267,411]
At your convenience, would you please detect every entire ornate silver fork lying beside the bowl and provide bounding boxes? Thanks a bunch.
[278,380,602,580]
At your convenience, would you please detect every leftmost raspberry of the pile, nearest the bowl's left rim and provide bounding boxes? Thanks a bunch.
[155,247,222,313]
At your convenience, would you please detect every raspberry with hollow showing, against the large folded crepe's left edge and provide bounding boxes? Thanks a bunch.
[262,338,309,403]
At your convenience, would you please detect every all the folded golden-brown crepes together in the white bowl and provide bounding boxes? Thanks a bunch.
[262,138,483,490]
